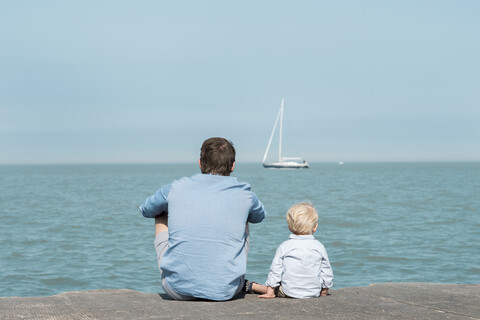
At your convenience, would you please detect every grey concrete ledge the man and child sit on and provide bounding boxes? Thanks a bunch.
[0,283,480,319]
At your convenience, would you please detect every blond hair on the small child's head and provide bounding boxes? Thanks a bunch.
[287,202,318,234]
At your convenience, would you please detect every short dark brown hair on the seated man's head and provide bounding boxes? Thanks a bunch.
[200,137,235,176]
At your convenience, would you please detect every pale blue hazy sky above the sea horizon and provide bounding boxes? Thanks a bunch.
[0,0,480,163]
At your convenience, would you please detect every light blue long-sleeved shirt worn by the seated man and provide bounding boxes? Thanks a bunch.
[140,174,265,300]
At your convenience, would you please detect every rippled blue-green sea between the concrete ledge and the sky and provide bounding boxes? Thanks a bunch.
[0,162,480,297]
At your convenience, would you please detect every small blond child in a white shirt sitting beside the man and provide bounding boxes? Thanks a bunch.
[247,203,333,298]
